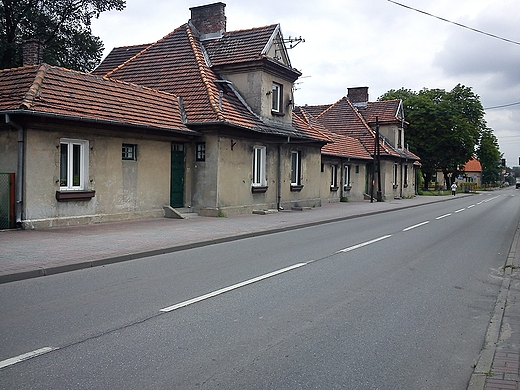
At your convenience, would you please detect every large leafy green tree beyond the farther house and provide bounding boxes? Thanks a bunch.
[379,84,487,185]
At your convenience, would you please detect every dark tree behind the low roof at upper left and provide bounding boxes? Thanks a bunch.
[0,0,126,71]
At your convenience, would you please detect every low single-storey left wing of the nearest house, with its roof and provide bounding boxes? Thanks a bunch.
[0,64,201,229]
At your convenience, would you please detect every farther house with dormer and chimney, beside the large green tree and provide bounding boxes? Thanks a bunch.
[301,87,419,199]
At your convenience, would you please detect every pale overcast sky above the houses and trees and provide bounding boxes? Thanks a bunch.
[92,0,520,166]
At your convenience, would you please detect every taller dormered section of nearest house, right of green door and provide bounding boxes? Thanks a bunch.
[94,3,328,216]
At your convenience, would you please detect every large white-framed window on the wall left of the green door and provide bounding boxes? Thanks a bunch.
[60,139,88,191]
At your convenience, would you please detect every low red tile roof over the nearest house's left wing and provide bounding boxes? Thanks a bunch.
[0,64,198,134]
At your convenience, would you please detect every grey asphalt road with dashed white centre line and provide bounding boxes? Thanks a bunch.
[0,191,520,390]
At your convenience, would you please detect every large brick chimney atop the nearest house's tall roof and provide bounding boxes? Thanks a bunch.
[190,2,226,39]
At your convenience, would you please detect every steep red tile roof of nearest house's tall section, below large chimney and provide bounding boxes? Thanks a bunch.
[96,24,320,140]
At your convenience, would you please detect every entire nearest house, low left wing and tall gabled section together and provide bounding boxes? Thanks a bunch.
[0,3,331,228]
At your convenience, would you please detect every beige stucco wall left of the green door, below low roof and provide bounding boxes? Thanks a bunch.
[23,128,170,228]
